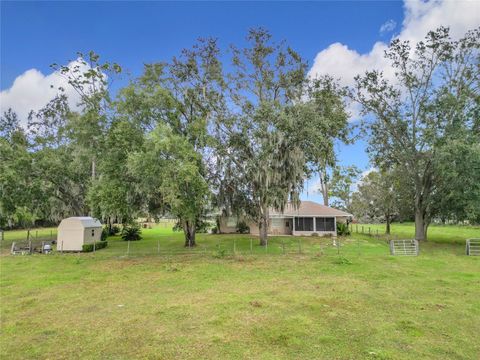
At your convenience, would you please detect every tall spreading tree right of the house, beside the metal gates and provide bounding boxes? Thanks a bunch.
[354,27,480,240]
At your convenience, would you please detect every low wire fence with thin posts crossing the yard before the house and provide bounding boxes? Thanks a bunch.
[0,221,388,258]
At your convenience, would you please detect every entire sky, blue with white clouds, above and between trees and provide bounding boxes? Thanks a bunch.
[0,0,480,200]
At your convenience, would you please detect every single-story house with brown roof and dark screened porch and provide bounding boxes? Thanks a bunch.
[219,201,353,236]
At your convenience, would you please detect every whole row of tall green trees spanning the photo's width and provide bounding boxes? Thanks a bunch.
[0,28,480,246]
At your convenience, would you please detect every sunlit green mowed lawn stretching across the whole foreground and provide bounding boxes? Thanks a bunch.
[0,225,480,359]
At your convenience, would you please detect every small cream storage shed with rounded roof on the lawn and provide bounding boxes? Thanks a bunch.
[57,216,102,251]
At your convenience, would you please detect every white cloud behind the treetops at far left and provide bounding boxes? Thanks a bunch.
[0,60,88,125]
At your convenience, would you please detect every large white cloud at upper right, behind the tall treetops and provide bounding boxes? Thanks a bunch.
[309,0,480,97]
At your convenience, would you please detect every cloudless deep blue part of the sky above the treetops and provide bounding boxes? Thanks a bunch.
[1,1,402,90]
